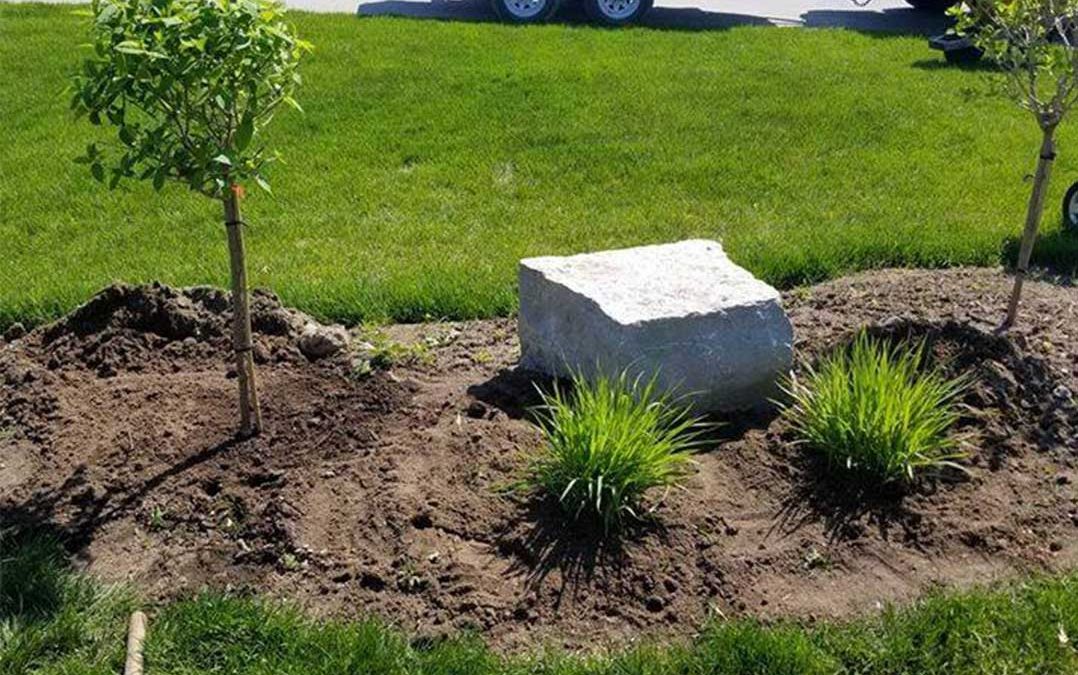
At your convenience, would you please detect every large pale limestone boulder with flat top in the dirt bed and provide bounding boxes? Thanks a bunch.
[520,239,793,412]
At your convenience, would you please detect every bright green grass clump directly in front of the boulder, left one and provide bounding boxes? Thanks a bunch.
[528,372,704,532]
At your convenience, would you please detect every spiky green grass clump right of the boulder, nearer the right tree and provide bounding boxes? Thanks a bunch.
[784,332,968,482]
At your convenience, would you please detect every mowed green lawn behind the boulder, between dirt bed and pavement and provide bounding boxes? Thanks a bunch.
[0,5,1078,325]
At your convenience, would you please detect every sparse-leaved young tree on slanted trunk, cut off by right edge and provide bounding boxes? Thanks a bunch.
[951,0,1078,328]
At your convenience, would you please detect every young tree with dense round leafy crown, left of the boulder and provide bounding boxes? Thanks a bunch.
[71,0,309,436]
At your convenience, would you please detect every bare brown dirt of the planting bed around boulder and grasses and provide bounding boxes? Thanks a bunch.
[0,265,1078,648]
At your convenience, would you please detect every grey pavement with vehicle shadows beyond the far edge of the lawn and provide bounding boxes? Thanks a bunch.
[8,0,946,35]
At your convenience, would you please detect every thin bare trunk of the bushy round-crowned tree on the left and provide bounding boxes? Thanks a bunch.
[224,188,262,436]
